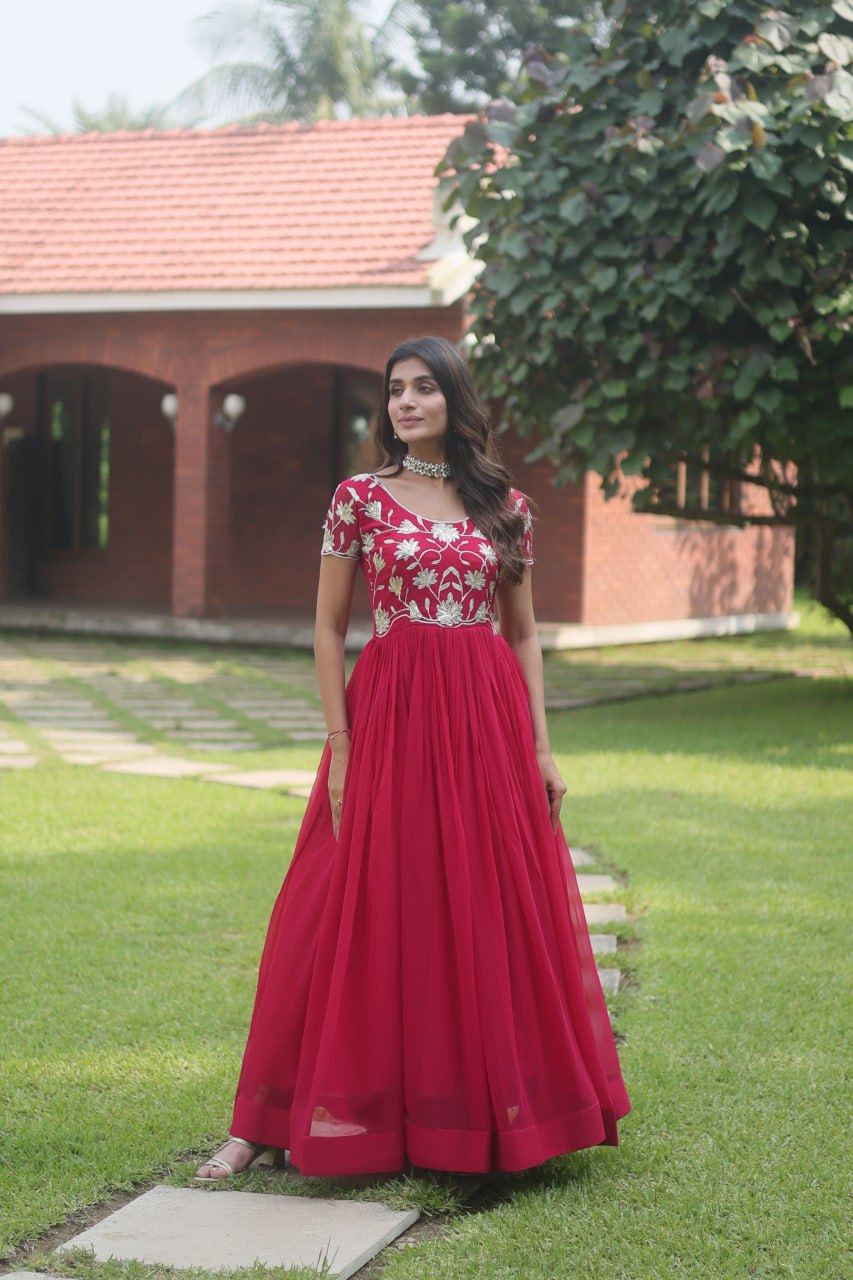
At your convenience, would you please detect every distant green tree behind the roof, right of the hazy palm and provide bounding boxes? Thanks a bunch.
[396,0,588,113]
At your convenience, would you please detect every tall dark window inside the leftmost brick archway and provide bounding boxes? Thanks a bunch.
[40,371,110,552]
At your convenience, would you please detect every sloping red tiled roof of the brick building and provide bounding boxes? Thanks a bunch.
[0,115,465,294]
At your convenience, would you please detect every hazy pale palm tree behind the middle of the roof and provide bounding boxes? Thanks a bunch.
[182,0,410,122]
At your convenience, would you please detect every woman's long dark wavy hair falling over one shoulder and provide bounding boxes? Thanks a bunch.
[377,335,524,582]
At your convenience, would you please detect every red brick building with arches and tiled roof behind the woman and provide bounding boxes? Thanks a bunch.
[0,115,793,643]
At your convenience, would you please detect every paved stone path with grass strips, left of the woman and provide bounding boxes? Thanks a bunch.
[0,637,325,796]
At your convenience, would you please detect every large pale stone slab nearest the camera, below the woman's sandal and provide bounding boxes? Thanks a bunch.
[58,1187,419,1280]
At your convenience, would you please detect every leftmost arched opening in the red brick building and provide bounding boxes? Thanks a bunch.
[0,364,174,608]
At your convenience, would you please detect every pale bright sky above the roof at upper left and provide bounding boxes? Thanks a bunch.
[0,0,388,137]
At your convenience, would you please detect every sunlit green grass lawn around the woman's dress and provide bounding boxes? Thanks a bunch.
[0,604,853,1280]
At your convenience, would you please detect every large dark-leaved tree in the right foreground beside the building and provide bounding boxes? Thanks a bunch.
[444,0,853,632]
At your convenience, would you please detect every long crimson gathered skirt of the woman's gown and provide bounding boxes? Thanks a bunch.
[231,623,629,1175]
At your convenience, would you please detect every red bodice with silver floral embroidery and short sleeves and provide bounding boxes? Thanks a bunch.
[323,475,533,636]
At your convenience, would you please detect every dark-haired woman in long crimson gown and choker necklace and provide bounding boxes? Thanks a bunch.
[199,338,629,1180]
